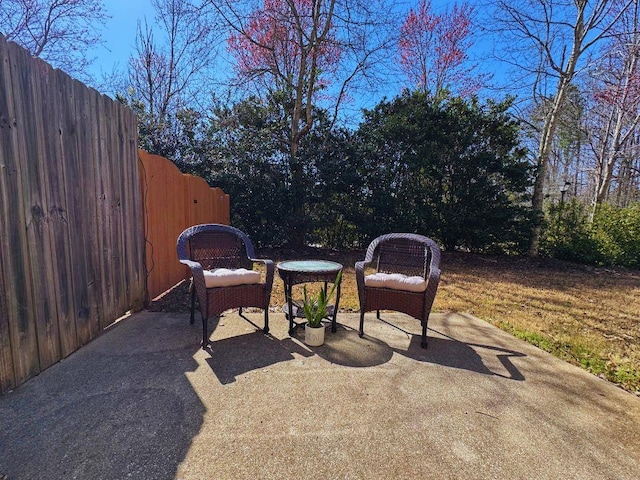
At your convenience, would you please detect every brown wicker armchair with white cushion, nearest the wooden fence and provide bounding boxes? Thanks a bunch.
[177,224,274,348]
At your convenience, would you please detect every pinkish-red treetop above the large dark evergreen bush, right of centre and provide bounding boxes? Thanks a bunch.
[398,0,482,98]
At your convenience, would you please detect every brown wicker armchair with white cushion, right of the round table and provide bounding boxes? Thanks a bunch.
[356,233,440,348]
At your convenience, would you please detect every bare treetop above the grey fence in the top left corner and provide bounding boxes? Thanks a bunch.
[0,0,107,81]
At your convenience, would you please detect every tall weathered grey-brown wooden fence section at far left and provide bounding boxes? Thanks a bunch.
[0,35,146,394]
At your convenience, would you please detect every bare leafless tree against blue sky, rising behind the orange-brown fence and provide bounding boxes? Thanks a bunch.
[119,0,216,158]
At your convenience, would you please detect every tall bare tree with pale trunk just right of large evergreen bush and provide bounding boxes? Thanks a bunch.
[497,0,632,255]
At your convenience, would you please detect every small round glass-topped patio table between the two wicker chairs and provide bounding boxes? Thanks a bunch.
[278,260,342,335]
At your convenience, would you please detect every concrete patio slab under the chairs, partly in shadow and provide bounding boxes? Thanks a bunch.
[0,312,640,480]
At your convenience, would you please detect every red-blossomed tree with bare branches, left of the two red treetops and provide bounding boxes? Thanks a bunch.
[228,0,341,157]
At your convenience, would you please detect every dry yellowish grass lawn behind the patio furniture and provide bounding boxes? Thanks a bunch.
[151,249,640,395]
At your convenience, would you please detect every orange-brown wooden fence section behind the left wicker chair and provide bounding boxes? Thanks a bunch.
[139,150,229,298]
